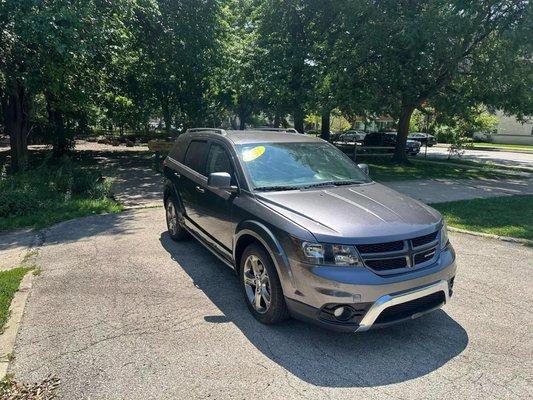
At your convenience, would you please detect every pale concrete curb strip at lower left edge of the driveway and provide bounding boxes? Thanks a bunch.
[0,271,34,380]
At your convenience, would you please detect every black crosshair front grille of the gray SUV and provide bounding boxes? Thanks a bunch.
[356,231,440,275]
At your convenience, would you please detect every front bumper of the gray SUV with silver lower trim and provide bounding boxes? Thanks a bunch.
[286,248,456,332]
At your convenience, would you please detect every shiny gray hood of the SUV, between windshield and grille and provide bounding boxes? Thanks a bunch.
[257,183,442,244]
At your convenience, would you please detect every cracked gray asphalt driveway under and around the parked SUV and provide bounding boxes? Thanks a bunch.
[11,208,533,400]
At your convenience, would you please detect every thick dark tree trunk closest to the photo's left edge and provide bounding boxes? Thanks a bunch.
[4,82,29,171]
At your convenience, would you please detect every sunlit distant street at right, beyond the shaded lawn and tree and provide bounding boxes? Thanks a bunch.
[419,146,533,168]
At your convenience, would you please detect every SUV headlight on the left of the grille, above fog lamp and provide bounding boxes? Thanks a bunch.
[301,242,363,267]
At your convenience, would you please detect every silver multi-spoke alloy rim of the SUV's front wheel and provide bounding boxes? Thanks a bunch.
[243,255,271,314]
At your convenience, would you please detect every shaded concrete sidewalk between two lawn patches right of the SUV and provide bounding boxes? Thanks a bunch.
[385,179,533,203]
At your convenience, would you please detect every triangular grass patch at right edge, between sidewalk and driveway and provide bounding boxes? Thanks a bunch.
[431,195,533,240]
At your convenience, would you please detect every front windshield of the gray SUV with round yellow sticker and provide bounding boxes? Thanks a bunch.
[237,142,370,190]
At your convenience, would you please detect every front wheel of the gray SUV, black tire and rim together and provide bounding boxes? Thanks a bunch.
[239,243,289,325]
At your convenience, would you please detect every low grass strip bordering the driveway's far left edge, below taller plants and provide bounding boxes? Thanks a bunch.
[0,198,123,231]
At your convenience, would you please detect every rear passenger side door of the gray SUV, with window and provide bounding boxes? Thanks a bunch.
[180,140,208,228]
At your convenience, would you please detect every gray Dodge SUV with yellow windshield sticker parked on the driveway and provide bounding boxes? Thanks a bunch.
[164,128,456,332]
